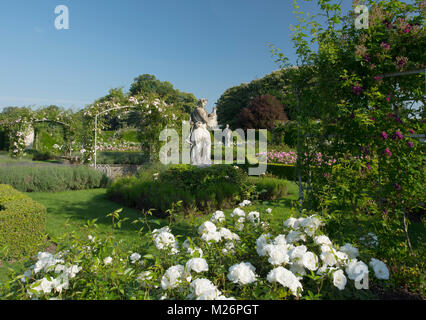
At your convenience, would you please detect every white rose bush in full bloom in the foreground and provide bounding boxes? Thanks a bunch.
[0,205,389,300]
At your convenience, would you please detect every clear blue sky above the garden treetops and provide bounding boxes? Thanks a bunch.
[0,0,351,110]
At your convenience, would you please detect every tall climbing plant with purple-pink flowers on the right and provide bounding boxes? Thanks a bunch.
[270,0,426,254]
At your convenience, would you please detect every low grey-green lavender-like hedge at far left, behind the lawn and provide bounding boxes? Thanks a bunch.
[0,165,108,192]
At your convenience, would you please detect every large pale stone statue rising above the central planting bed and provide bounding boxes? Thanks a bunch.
[187,99,217,166]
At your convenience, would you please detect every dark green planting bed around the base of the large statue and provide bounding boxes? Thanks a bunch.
[107,165,249,216]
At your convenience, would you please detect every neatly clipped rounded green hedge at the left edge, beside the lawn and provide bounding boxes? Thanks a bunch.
[0,184,46,260]
